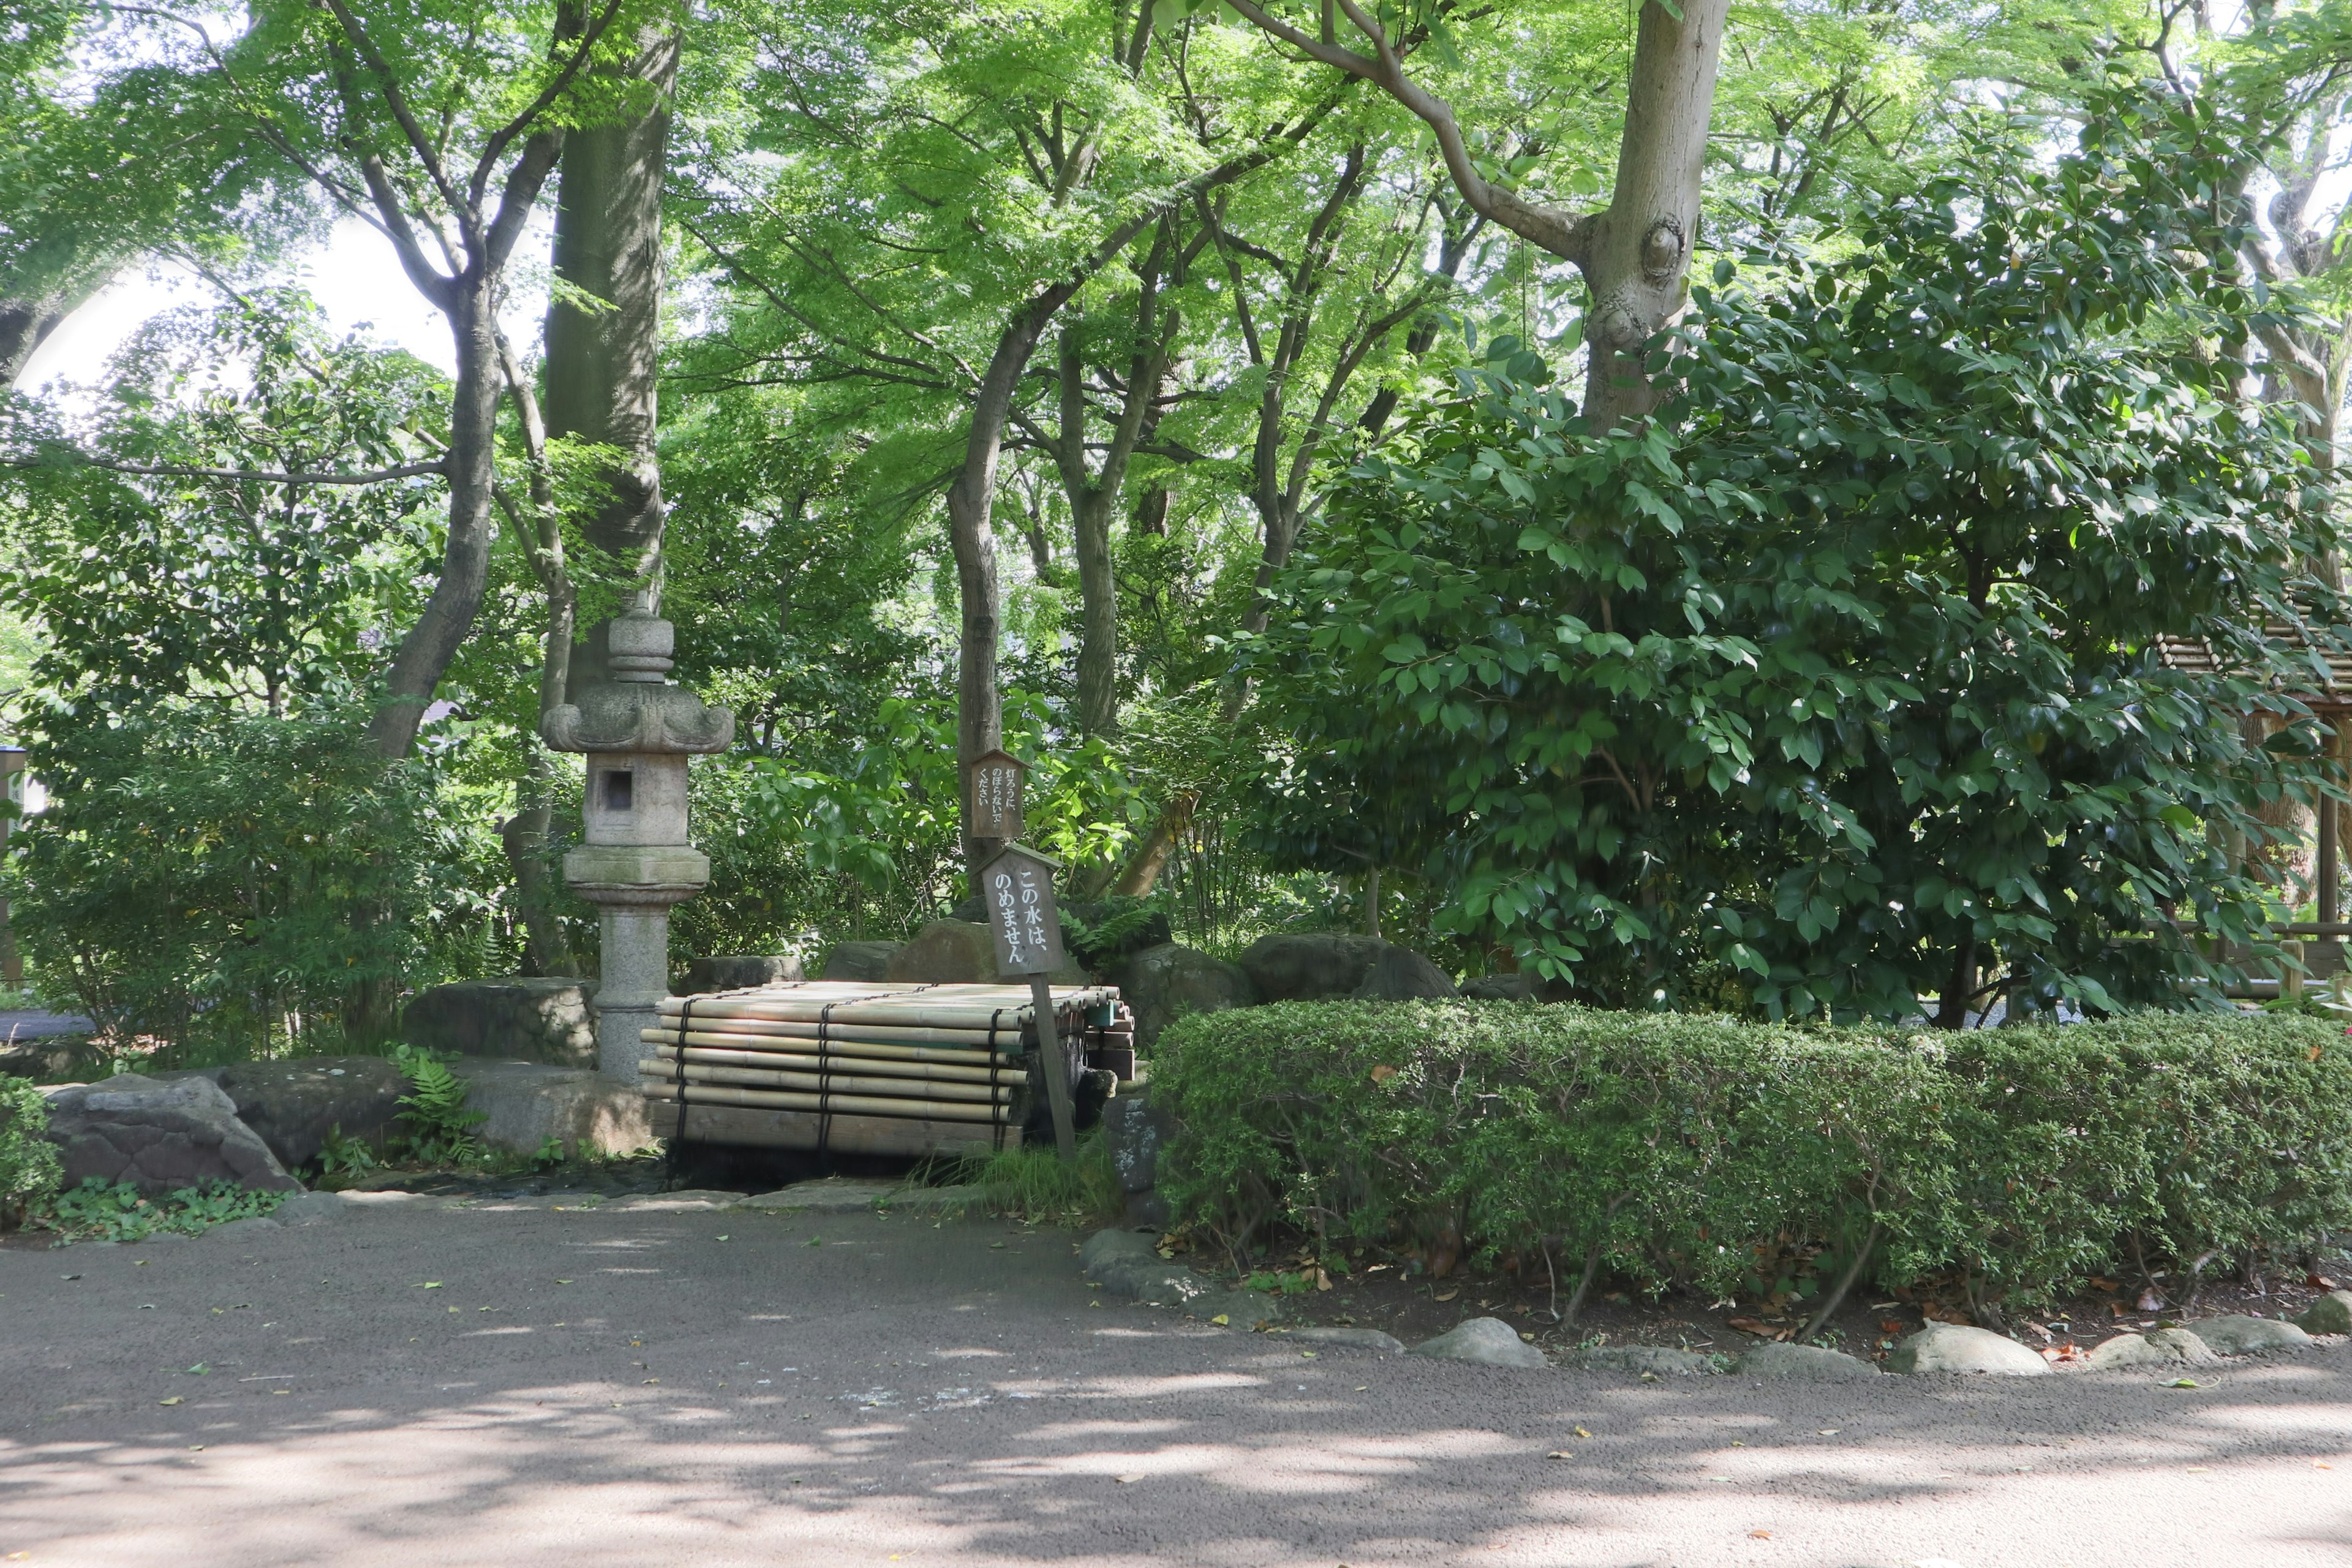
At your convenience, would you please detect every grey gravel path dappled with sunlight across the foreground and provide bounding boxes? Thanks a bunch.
[0,1197,2352,1568]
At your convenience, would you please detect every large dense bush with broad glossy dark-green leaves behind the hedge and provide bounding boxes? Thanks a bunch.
[1244,92,2352,1025]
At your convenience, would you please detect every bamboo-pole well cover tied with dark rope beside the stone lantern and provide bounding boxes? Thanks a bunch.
[638,980,1134,1156]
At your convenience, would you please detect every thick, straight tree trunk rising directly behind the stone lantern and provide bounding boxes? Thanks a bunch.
[546,28,677,609]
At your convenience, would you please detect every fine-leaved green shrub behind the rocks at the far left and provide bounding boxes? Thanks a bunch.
[5,707,496,1065]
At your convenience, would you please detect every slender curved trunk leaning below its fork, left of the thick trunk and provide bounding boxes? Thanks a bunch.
[367,280,503,757]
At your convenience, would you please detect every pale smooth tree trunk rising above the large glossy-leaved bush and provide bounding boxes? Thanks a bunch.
[1576,0,1731,430]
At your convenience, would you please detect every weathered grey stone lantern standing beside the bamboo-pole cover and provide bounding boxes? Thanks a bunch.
[538,606,734,1084]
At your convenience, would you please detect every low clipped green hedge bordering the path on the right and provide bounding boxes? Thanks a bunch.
[1153,1001,2352,1305]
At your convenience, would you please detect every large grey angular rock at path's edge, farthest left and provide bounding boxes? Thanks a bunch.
[50,1072,301,1197]
